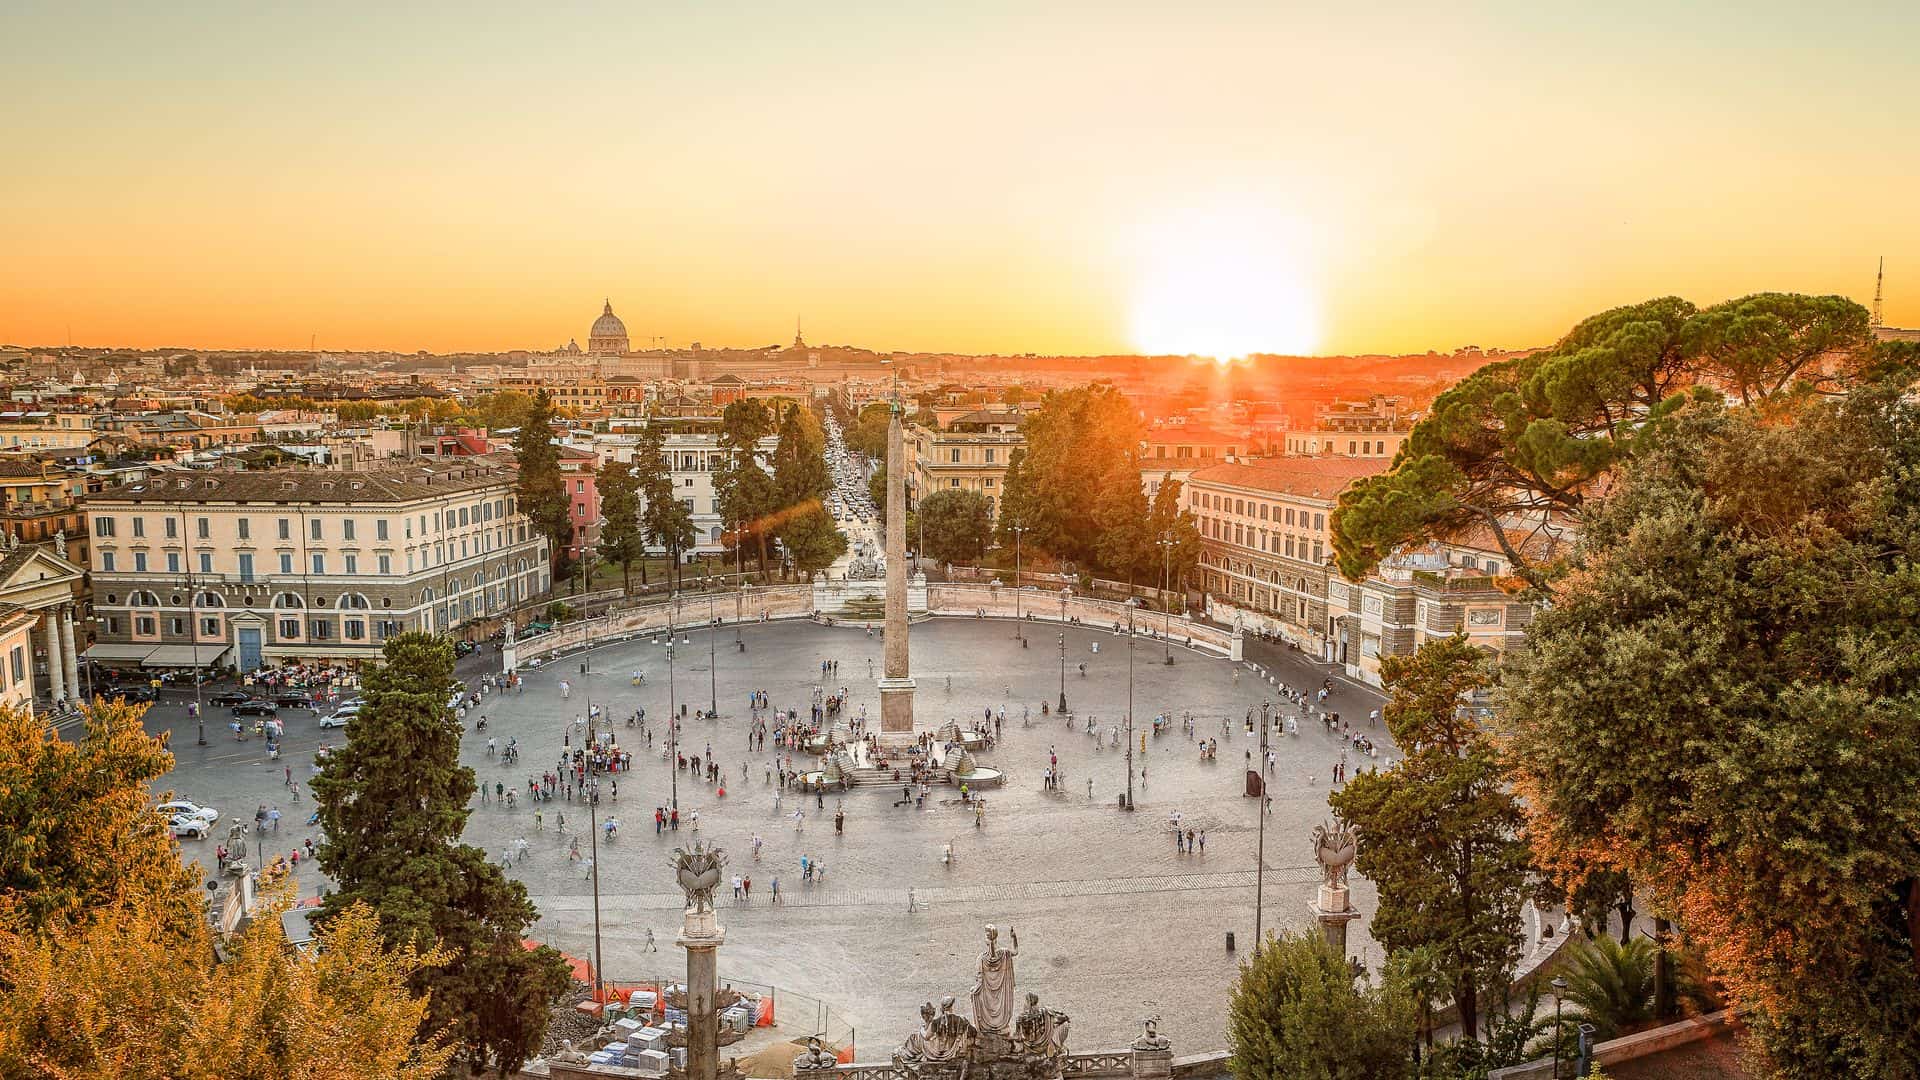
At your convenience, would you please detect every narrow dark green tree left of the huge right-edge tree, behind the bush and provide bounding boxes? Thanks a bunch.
[1327,636,1528,1038]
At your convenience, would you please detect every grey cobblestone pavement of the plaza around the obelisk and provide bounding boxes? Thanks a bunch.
[148,619,1388,1059]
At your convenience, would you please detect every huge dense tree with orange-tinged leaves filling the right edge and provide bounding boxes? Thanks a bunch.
[1505,386,1920,1078]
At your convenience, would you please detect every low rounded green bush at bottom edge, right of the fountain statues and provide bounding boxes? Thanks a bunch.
[1227,932,1413,1080]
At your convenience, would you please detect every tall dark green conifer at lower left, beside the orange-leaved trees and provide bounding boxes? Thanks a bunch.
[313,632,568,1072]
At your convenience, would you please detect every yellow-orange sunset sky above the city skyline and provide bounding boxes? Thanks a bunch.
[0,0,1920,354]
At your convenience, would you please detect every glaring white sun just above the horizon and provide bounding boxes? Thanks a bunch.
[1129,211,1319,361]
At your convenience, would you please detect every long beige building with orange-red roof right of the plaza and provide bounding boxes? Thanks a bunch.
[1187,457,1386,655]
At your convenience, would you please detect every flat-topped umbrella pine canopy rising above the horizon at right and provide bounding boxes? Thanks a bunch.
[1332,294,1874,586]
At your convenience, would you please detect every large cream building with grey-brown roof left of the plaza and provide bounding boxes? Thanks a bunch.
[86,463,551,671]
